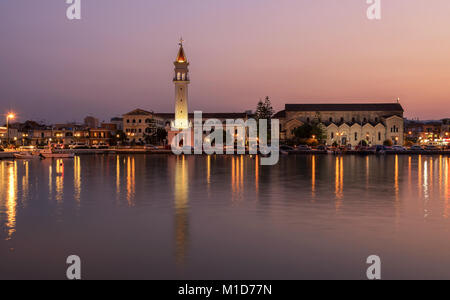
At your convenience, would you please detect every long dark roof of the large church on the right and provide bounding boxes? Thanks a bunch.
[285,103,403,112]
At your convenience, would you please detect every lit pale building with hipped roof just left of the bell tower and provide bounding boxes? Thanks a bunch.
[123,109,164,144]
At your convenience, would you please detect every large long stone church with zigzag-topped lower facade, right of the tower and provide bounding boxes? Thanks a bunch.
[274,103,404,146]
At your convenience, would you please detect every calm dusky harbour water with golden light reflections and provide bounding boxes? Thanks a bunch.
[0,155,450,279]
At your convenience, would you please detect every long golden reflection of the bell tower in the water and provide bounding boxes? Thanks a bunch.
[174,155,189,265]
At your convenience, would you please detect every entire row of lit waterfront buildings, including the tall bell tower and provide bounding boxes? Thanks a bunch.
[0,42,449,146]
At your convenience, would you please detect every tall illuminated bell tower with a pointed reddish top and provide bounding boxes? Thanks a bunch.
[172,39,190,129]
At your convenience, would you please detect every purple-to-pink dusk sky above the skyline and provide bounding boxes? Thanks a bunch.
[0,0,450,123]
